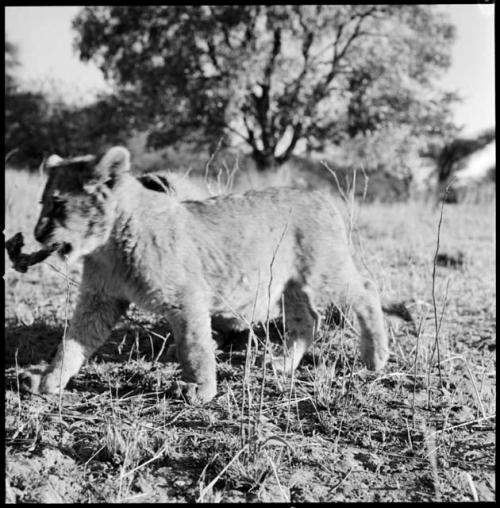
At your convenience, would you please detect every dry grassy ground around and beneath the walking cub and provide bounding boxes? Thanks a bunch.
[5,169,496,503]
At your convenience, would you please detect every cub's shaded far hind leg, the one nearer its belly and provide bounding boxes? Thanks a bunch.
[273,281,320,373]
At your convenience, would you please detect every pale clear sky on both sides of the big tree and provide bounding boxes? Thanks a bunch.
[5,3,495,135]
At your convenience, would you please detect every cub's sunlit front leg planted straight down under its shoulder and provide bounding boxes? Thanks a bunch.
[168,291,217,404]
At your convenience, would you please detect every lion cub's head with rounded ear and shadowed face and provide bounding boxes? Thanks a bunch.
[35,146,130,261]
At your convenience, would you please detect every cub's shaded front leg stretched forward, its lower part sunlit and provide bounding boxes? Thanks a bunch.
[19,291,128,394]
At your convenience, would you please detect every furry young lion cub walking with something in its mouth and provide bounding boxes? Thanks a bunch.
[22,147,389,403]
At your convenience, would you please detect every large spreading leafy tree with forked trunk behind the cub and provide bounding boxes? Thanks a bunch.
[73,5,454,169]
